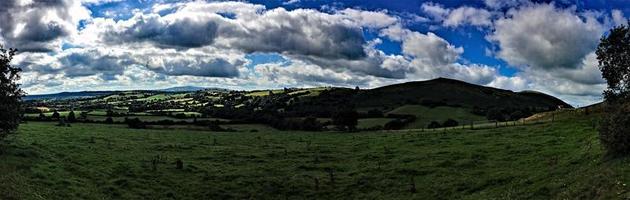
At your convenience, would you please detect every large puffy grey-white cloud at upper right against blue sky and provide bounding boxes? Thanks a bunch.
[488,4,604,69]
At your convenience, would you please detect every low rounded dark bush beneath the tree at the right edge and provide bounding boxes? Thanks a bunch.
[599,103,630,156]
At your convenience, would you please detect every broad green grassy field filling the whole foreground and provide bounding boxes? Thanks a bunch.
[0,113,630,199]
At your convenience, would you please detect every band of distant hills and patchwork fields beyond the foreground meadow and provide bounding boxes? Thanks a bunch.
[21,78,571,130]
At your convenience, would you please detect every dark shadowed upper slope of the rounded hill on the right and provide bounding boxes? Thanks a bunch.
[356,78,571,108]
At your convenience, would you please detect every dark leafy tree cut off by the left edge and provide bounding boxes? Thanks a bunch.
[0,45,24,139]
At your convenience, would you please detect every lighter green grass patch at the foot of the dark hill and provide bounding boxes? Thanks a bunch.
[388,105,486,129]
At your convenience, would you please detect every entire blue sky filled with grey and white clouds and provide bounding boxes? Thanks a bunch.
[0,0,630,106]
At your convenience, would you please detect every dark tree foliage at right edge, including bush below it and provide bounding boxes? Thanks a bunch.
[596,21,630,156]
